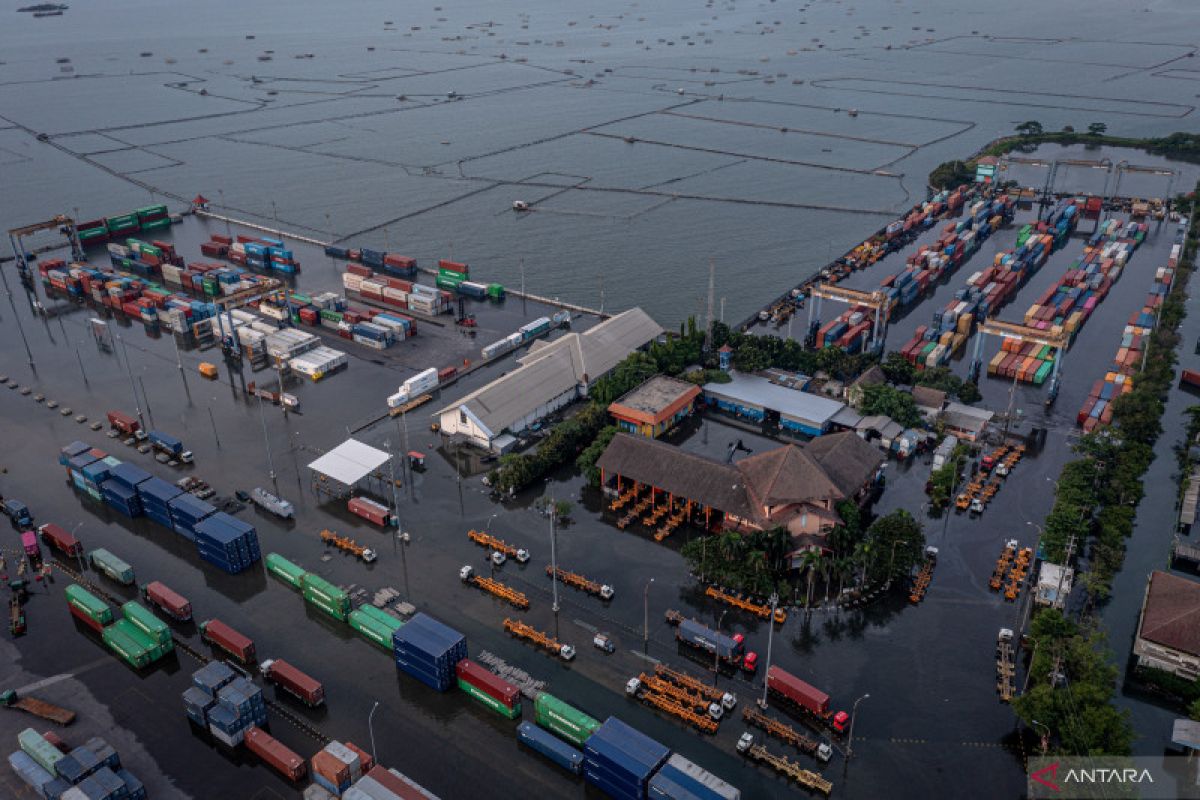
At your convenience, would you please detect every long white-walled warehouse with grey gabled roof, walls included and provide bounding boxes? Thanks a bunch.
[438,308,662,452]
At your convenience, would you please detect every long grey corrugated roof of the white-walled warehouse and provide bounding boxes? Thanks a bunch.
[440,308,662,437]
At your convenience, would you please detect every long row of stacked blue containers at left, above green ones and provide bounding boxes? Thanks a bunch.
[59,441,262,575]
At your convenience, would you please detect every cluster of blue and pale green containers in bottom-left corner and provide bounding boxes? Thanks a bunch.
[8,728,146,800]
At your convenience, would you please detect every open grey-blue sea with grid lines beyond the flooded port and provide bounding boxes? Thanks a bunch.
[0,0,1200,326]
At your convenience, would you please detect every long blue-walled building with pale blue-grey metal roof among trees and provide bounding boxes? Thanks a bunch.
[704,372,845,437]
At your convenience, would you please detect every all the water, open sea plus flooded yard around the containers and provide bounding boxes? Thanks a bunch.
[0,0,1200,800]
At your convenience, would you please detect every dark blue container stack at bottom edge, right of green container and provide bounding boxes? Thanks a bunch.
[583,717,671,800]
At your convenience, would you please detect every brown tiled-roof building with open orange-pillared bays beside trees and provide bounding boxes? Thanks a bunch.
[596,432,884,545]
